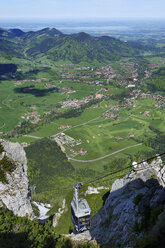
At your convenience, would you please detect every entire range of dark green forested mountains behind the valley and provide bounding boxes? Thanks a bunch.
[0,28,137,63]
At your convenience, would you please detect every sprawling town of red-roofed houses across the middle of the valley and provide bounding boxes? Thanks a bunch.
[12,58,165,129]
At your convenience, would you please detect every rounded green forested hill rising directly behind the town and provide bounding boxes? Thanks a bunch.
[27,32,134,63]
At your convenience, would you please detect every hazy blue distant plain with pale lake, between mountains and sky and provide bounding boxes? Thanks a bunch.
[0,20,165,38]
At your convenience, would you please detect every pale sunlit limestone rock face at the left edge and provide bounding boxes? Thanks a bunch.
[0,140,33,218]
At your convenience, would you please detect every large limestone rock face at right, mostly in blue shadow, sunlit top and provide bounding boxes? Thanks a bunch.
[90,157,165,248]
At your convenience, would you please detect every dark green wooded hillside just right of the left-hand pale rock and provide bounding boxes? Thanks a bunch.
[26,138,74,195]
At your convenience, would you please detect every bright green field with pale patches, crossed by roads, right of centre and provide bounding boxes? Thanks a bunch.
[20,95,164,166]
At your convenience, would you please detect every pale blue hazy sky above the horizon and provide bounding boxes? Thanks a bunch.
[0,0,165,19]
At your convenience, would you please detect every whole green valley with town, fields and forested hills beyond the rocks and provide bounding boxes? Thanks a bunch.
[0,28,165,233]
